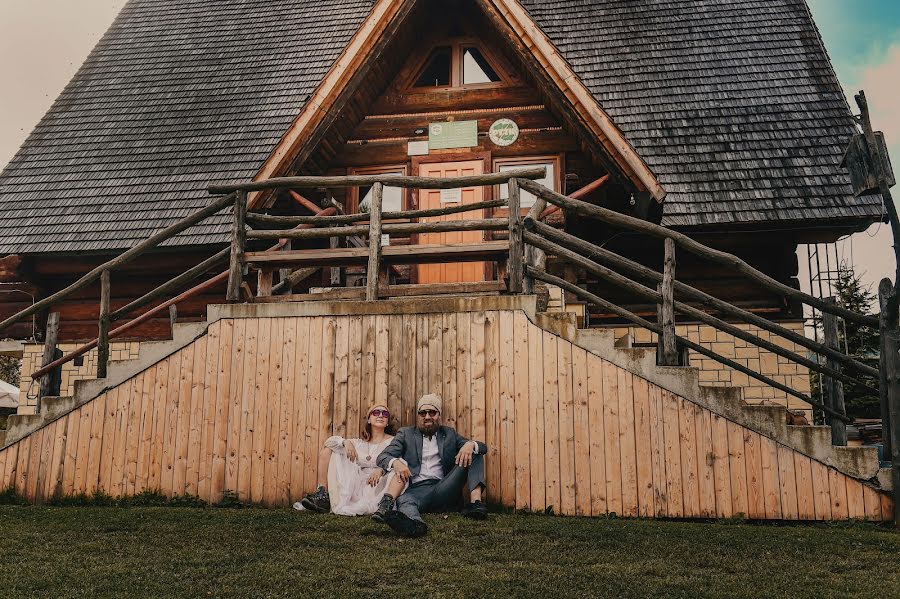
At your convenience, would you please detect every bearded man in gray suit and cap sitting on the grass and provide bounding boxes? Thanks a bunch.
[372,394,487,537]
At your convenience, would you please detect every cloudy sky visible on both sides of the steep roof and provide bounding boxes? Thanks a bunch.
[0,0,900,300]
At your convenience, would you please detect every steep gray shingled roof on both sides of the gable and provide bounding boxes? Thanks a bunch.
[0,0,881,253]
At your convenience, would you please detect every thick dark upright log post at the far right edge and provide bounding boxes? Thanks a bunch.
[878,279,900,527]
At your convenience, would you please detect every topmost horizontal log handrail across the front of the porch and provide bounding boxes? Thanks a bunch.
[207,166,547,194]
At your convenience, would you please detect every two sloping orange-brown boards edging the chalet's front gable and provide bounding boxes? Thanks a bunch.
[251,0,666,203]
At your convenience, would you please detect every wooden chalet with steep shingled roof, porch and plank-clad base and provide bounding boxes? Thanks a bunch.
[0,0,890,519]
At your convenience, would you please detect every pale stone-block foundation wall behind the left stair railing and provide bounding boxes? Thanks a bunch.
[18,341,141,414]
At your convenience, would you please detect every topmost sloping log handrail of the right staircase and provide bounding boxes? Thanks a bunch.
[520,180,878,327]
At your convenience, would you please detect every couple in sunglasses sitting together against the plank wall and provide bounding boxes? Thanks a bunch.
[295,394,487,537]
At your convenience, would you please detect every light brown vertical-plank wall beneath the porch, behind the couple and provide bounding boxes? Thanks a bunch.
[0,311,891,520]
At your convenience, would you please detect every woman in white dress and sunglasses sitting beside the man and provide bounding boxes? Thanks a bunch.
[294,405,394,516]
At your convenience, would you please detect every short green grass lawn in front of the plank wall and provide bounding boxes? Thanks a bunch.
[0,506,900,598]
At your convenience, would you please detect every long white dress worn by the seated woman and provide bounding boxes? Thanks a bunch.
[325,437,394,516]
